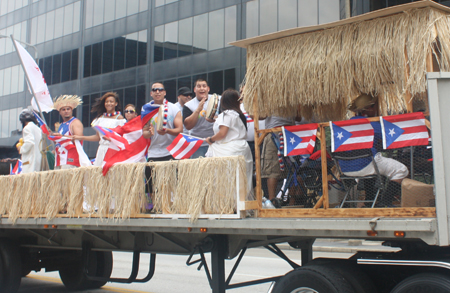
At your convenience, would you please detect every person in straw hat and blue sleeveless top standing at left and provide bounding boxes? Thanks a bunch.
[53,95,84,169]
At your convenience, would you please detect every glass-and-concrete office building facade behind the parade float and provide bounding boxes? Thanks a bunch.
[0,0,449,159]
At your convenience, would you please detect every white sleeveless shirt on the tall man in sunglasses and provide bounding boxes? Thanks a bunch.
[148,100,180,158]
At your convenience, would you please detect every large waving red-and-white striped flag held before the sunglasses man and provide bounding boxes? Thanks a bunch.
[94,116,150,176]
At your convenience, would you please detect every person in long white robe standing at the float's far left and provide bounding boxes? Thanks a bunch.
[17,109,42,174]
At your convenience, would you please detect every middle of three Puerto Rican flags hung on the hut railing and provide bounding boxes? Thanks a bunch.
[330,118,374,152]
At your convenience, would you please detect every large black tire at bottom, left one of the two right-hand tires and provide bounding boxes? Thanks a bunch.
[272,265,355,293]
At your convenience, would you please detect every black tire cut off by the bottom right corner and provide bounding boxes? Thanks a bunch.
[391,273,450,293]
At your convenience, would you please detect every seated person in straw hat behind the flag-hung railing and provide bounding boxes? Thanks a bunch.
[339,93,409,204]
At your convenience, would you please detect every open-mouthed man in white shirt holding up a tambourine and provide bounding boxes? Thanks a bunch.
[183,79,218,159]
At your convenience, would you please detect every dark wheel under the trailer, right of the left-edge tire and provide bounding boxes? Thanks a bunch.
[59,251,113,290]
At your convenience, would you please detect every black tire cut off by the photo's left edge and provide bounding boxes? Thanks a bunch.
[0,238,22,293]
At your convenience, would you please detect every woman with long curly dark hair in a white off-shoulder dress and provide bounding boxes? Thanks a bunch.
[73,92,127,167]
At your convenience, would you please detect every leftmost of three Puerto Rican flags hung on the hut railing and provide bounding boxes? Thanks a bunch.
[281,123,318,157]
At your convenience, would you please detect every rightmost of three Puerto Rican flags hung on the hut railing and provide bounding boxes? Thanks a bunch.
[380,112,429,149]
